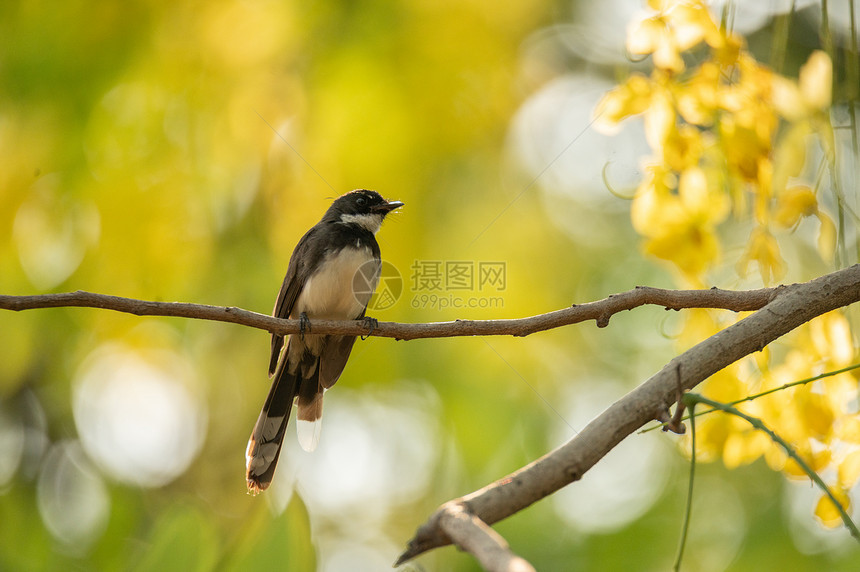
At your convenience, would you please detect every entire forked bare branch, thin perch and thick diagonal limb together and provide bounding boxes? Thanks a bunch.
[0,265,860,571]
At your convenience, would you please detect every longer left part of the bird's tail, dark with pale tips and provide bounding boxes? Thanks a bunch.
[245,356,301,494]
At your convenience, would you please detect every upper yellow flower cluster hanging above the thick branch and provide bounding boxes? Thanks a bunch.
[595,0,836,286]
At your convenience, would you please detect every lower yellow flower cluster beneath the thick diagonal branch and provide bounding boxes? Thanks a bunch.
[685,310,860,526]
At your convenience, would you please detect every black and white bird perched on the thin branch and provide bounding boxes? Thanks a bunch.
[245,189,404,494]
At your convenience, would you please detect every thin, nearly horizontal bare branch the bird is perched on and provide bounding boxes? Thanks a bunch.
[0,286,778,340]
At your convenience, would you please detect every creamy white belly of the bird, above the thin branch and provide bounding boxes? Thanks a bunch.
[291,248,378,320]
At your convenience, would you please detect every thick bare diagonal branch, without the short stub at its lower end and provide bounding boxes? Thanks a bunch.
[397,265,860,564]
